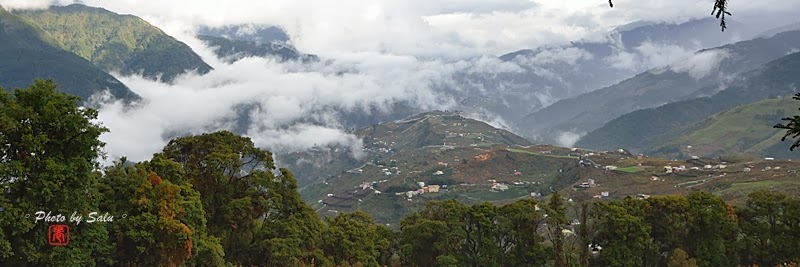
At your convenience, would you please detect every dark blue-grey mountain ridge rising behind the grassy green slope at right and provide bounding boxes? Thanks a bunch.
[575,50,800,157]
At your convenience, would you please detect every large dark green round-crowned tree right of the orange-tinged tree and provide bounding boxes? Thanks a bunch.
[153,131,322,266]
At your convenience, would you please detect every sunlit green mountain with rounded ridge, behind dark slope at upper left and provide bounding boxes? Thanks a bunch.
[14,4,212,82]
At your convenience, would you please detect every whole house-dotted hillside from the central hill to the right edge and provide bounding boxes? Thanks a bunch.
[288,112,800,225]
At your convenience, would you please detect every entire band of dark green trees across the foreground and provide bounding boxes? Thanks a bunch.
[0,80,800,267]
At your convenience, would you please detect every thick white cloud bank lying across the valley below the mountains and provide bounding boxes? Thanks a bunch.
[94,39,519,161]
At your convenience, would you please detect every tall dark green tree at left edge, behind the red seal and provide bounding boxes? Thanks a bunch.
[0,80,112,266]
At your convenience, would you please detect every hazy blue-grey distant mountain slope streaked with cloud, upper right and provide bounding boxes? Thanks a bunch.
[453,18,751,122]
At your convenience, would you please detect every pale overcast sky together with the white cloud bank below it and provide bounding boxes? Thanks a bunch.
[0,0,800,161]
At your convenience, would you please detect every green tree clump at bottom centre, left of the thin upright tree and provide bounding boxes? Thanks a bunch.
[399,200,548,266]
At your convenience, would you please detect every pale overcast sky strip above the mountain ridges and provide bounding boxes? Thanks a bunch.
[6,0,800,57]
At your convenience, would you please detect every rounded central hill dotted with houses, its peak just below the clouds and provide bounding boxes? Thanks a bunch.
[278,112,578,223]
